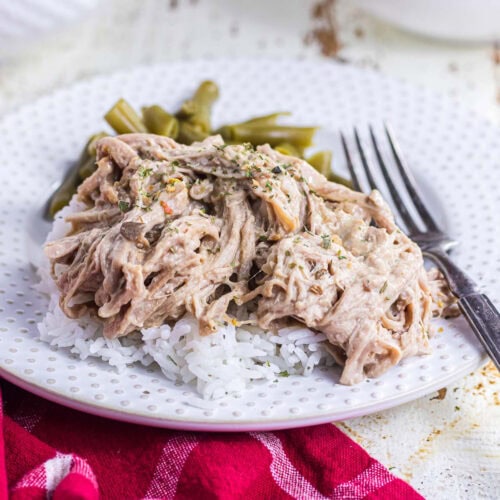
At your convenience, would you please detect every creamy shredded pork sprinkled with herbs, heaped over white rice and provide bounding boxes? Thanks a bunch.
[45,134,456,384]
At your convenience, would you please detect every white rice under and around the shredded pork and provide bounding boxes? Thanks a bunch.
[36,200,333,399]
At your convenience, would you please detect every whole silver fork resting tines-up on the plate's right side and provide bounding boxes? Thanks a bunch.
[340,125,500,370]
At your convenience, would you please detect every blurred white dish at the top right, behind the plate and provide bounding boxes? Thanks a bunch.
[356,0,500,42]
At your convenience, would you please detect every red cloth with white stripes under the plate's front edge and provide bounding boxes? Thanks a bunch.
[0,381,422,500]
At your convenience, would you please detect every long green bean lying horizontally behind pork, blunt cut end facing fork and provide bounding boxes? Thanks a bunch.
[227,125,316,148]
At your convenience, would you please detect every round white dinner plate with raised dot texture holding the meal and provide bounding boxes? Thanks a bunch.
[0,59,500,430]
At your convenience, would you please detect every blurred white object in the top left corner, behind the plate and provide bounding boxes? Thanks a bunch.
[0,0,99,57]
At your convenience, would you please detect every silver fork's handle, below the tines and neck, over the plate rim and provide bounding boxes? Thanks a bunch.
[424,250,500,370]
